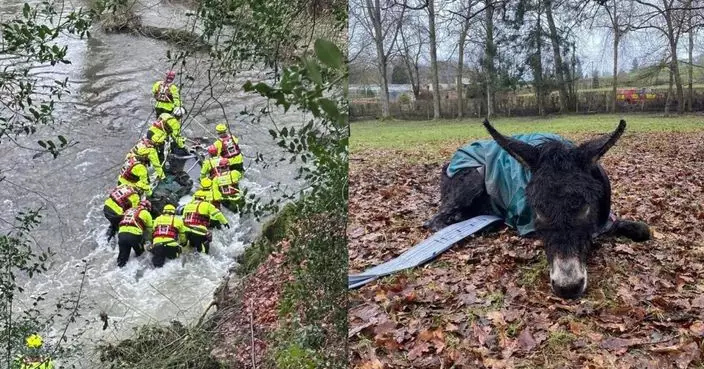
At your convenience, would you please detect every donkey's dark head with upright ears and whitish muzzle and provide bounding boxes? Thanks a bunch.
[484,120,626,298]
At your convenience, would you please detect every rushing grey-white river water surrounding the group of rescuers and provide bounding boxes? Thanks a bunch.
[0,0,303,367]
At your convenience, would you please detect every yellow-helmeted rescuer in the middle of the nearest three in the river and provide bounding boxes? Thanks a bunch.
[150,204,187,268]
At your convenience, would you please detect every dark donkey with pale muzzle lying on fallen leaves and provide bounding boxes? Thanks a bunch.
[424,120,651,299]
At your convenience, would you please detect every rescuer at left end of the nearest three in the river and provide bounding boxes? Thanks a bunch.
[117,200,154,268]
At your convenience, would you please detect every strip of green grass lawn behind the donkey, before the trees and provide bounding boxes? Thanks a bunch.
[350,114,704,152]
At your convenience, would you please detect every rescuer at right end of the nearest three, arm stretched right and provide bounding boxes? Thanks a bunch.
[183,194,230,254]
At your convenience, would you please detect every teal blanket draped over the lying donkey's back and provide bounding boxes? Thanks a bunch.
[447,133,574,236]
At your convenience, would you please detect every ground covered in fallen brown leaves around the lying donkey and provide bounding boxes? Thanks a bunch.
[347,132,704,369]
